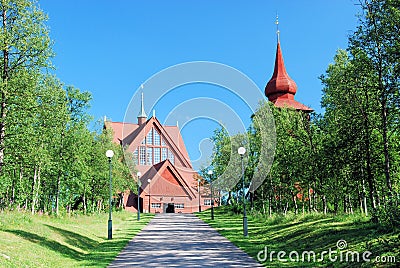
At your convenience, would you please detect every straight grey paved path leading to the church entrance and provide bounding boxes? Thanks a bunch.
[109,214,263,268]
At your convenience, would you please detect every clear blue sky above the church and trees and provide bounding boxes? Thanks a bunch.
[39,0,360,170]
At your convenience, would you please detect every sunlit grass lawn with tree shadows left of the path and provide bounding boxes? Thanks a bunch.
[0,211,153,267]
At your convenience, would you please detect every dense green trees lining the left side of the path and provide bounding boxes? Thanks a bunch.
[0,0,134,215]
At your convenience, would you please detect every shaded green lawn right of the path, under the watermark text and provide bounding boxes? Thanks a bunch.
[197,207,400,267]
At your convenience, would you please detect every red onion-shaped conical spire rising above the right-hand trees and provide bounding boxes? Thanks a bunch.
[265,41,297,102]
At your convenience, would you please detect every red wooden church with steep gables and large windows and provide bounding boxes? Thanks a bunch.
[105,93,212,213]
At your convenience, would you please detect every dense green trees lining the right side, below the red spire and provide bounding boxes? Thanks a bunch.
[212,0,400,228]
